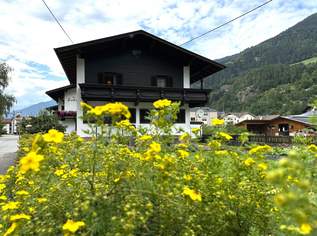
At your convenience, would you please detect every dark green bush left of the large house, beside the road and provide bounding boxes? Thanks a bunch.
[19,111,65,134]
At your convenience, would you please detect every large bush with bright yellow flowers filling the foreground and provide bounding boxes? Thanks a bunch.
[0,100,317,235]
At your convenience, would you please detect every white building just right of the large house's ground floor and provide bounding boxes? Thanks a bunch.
[190,107,218,125]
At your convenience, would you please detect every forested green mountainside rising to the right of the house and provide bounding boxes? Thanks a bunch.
[204,13,317,115]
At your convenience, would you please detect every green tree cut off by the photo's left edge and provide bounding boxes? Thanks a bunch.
[0,62,15,120]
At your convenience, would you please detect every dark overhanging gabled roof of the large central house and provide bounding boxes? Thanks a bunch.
[55,30,225,84]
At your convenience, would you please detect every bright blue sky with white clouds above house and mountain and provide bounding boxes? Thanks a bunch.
[0,0,317,109]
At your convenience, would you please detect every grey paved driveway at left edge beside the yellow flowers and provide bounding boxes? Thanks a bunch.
[0,135,19,174]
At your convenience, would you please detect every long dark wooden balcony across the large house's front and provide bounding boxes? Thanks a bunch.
[79,84,210,106]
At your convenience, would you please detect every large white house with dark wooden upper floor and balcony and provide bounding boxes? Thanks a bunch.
[46,30,224,136]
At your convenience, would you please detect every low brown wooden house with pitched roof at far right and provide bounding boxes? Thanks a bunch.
[236,115,313,136]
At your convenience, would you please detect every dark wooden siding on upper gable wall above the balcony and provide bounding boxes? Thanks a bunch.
[85,50,183,88]
